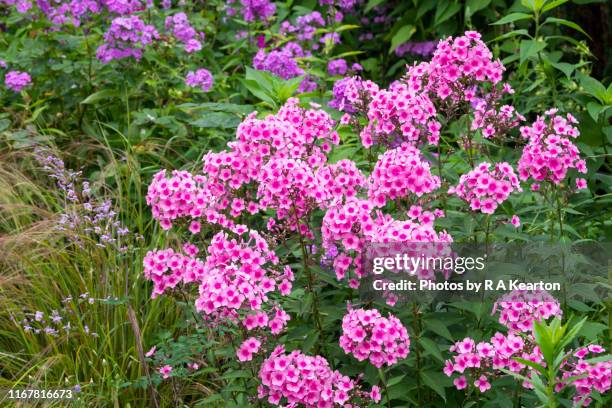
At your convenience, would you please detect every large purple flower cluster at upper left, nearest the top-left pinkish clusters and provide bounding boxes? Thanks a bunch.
[96,16,159,64]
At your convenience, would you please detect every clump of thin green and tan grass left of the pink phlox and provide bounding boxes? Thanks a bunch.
[0,146,190,406]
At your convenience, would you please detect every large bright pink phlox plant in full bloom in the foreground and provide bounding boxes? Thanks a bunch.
[144,31,610,407]
